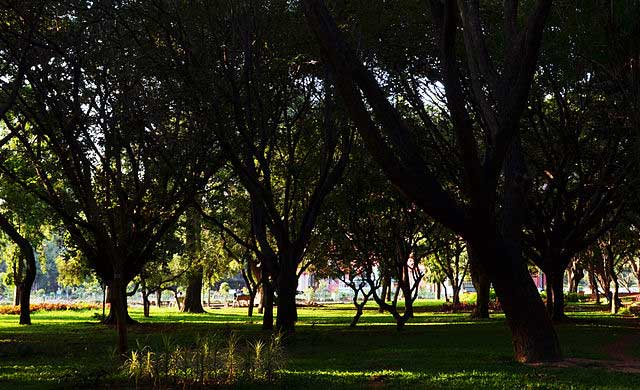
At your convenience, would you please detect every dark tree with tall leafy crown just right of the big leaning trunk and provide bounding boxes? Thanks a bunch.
[522,4,638,321]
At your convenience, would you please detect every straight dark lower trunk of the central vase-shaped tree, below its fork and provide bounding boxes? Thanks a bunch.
[276,260,298,333]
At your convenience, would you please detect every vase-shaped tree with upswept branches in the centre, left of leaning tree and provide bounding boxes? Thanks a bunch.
[157,1,351,332]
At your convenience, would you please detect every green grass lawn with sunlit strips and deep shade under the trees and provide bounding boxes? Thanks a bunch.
[0,302,640,389]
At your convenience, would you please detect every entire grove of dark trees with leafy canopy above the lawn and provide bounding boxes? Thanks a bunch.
[0,0,640,362]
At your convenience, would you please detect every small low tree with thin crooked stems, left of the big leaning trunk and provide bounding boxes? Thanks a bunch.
[319,145,433,329]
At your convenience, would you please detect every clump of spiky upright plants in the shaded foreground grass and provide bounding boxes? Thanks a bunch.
[122,333,285,388]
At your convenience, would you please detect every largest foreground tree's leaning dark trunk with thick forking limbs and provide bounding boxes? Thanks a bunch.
[303,0,561,361]
